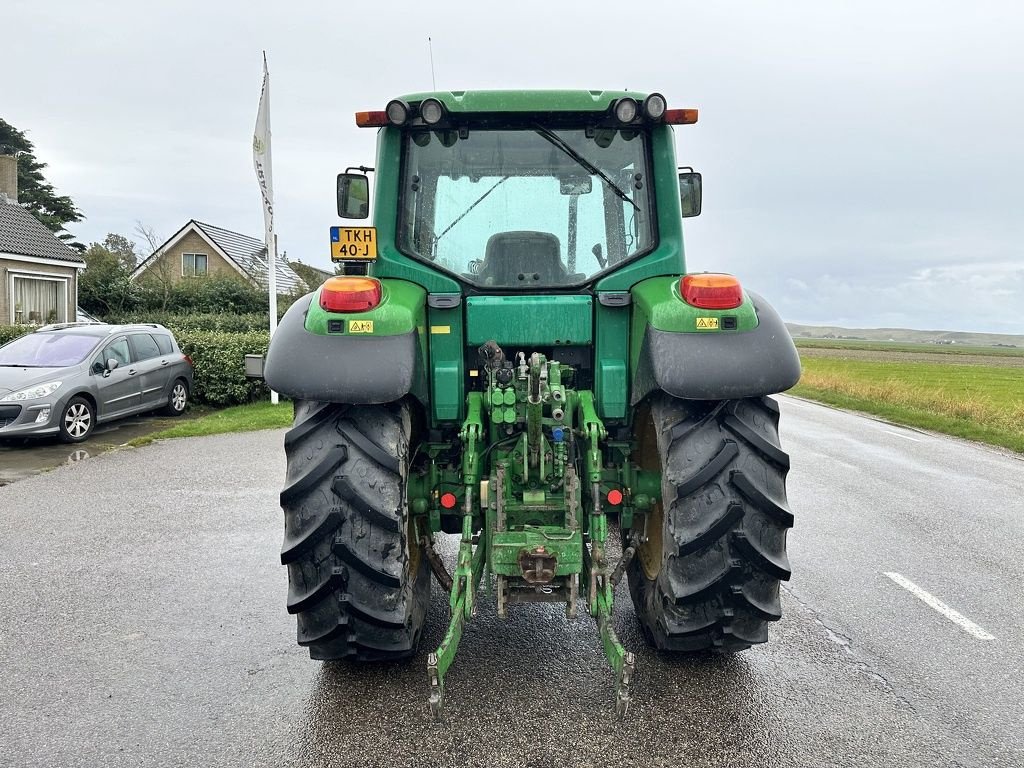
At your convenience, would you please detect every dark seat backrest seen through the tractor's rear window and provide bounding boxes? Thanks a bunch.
[477,231,566,288]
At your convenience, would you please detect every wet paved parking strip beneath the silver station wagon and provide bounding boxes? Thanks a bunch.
[0,412,189,485]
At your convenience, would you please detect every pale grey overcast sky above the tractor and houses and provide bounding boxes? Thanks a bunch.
[8,0,1024,333]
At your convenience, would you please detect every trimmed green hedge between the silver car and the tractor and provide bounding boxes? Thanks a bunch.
[175,331,270,406]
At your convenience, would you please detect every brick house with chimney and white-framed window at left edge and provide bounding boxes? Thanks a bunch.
[0,155,85,326]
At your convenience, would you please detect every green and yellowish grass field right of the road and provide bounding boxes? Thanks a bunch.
[791,339,1024,453]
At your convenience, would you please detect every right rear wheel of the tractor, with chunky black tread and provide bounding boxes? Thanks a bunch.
[627,394,793,651]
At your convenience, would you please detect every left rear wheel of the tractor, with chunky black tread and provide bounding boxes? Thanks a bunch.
[281,400,430,660]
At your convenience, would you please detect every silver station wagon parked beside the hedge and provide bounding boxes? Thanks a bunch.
[0,324,193,442]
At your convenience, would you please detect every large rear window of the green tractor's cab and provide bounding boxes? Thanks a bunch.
[398,126,654,289]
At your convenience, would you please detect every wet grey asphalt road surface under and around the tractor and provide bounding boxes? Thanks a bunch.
[0,398,1024,768]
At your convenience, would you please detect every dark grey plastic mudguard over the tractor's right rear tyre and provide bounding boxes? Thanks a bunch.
[631,291,800,406]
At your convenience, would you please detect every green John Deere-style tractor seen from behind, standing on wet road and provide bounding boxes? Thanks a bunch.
[264,91,800,717]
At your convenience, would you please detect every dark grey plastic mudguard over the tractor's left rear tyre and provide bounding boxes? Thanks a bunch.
[263,294,426,404]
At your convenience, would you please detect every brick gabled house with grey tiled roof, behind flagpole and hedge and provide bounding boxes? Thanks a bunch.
[131,224,307,294]
